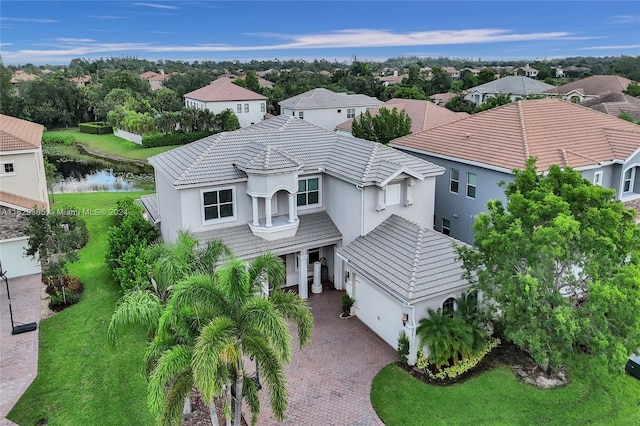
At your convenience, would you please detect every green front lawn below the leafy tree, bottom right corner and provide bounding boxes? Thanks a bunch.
[371,357,640,426]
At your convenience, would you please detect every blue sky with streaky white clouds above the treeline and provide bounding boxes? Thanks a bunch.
[0,0,640,65]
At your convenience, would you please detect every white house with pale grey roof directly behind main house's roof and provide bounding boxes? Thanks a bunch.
[278,88,382,130]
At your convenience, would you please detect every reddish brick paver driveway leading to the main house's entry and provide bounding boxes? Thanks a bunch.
[245,290,396,426]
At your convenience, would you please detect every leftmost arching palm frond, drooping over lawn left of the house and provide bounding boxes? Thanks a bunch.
[107,290,162,344]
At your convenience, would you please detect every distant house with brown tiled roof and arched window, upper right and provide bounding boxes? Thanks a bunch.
[545,75,631,102]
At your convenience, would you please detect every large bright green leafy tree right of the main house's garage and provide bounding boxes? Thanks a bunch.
[458,159,640,369]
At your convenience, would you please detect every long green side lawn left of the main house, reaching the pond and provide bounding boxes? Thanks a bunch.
[8,192,154,426]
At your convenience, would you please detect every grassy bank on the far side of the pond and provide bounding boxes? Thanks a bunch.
[46,129,176,160]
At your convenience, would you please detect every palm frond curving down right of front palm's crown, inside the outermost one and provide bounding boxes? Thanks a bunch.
[238,296,291,362]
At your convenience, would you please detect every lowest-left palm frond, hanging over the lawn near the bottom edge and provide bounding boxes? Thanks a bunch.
[147,345,193,417]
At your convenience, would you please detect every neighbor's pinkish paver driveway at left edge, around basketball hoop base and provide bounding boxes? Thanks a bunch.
[0,272,41,426]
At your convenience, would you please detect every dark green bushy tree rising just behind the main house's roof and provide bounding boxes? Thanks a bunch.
[351,107,411,145]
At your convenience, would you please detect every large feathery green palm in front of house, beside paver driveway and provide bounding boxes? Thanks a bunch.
[149,253,313,425]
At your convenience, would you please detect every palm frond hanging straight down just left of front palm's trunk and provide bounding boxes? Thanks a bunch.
[192,317,242,404]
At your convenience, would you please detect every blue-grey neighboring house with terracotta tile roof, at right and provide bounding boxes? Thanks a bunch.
[391,99,640,243]
